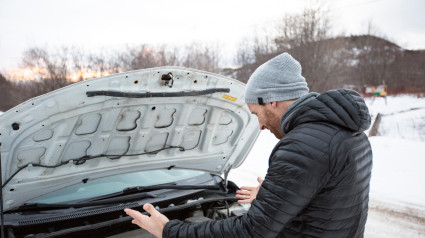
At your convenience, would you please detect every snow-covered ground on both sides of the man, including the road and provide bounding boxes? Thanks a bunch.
[229,95,425,238]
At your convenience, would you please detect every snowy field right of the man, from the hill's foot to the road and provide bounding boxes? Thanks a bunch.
[366,95,425,210]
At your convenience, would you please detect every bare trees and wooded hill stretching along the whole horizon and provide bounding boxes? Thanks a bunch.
[0,8,425,111]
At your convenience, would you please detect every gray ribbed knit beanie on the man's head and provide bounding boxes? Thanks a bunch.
[245,53,309,104]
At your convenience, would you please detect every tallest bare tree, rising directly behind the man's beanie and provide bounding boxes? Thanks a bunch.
[275,7,341,92]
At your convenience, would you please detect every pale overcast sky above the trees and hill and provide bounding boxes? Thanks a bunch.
[0,0,425,70]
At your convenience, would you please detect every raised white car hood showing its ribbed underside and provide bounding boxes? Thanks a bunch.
[0,67,259,210]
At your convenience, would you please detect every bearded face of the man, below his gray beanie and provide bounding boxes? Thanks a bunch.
[248,103,283,140]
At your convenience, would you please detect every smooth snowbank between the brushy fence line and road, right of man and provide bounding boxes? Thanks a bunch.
[370,136,425,208]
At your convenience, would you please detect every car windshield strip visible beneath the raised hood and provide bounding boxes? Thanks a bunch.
[27,169,205,204]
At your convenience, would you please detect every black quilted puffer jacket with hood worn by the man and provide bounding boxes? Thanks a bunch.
[163,90,372,238]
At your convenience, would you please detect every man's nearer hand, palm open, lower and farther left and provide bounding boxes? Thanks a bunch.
[124,203,169,238]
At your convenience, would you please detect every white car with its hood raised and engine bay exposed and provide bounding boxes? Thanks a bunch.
[0,67,259,238]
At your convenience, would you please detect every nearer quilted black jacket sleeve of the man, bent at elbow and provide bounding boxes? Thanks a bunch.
[163,137,329,237]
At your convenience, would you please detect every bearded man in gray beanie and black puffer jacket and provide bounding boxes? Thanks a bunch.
[125,53,372,238]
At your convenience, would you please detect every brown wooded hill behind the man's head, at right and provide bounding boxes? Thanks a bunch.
[222,35,425,93]
